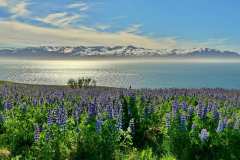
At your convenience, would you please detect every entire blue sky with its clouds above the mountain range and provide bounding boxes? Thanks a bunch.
[0,0,240,52]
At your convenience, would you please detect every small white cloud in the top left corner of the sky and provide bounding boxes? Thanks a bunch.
[0,0,29,18]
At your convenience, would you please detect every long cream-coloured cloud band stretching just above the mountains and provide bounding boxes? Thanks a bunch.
[0,21,236,51]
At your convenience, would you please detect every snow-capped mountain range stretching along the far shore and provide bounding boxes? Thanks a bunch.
[0,46,240,57]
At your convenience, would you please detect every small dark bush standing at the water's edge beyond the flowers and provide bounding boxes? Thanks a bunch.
[67,77,96,88]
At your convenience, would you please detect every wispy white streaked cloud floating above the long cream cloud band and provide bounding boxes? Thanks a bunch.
[36,12,81,27]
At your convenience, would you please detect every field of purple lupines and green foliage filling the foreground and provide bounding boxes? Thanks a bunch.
[0,83,240,160]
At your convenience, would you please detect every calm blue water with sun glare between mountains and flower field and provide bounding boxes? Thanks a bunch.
[0,57,240,89]
